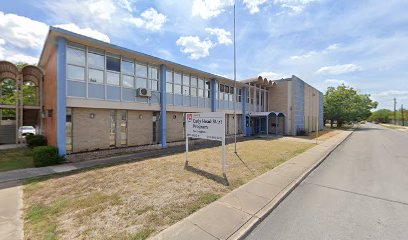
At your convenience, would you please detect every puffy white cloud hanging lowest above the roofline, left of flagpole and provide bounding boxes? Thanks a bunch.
[176,36,214,60]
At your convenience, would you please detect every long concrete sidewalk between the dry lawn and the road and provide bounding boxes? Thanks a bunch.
[151,131,352,240]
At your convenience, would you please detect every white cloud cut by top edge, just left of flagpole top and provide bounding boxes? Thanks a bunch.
[192,0,234,19]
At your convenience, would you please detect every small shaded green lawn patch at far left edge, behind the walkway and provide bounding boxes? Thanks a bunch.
[0,148,34,172]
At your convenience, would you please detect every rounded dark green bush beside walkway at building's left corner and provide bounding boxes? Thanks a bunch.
[33,146,64,167]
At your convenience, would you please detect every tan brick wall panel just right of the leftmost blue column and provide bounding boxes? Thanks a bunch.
[72,108,110,152]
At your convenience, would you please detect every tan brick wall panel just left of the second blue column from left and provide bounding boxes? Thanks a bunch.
[128,111,153,146]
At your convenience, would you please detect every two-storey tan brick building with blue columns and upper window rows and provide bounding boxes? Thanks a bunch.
[0,27,321,154]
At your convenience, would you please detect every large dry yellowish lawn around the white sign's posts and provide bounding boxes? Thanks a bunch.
[24,139,314,239]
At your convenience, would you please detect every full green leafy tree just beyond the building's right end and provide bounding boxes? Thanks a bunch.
[324,85,378,127]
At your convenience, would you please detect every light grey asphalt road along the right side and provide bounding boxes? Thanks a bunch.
[246,124,408,240]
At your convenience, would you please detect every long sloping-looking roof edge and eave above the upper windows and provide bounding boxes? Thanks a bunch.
[38,26,248,87]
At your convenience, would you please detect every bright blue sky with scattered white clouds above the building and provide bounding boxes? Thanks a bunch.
[0,0,408,109]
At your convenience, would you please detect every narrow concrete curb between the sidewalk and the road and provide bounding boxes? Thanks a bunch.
[233,128,355,240]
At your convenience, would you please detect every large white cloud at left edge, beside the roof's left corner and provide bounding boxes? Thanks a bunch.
[0,11,48,48]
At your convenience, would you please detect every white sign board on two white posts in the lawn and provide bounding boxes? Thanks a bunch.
[185,112,227,177]
